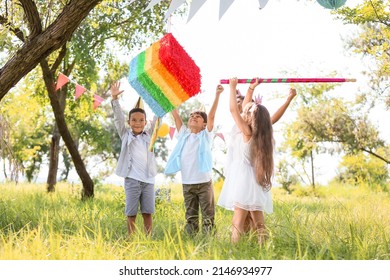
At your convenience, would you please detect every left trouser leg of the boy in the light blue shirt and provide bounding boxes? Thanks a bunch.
[183,184,199,234]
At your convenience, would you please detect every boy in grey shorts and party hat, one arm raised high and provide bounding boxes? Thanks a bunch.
[111,82,157,235]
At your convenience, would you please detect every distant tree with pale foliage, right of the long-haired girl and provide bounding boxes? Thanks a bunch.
[282,82,389,187]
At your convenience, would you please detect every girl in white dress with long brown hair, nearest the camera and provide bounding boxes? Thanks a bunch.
[218,78,274,243]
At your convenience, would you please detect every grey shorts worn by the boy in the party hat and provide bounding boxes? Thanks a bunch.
[125,178,155,216]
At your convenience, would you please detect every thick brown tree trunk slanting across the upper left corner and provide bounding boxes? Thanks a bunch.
[0,0,102,101]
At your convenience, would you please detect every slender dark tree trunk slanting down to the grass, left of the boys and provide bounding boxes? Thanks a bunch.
[41,60,94,199]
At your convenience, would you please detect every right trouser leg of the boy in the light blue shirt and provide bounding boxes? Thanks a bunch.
[198,181,215,233]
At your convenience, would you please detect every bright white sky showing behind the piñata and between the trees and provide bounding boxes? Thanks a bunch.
[106,0,380,186]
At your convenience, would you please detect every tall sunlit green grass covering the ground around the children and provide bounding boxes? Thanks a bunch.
[0,184,390,260]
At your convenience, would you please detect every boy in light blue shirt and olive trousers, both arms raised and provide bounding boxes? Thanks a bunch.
[165,85,224,234]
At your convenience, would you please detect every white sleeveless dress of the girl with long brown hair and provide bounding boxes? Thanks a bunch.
[217,126,273,214]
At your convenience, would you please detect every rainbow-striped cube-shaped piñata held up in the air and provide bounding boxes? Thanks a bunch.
[129,33,201,117]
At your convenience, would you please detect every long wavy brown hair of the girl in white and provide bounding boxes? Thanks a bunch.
[243,102,274,190]
